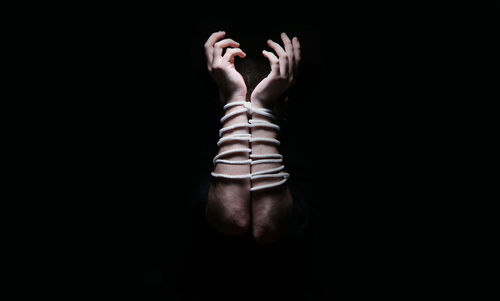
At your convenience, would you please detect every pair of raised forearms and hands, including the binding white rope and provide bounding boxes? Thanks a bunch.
[204,31,300,242]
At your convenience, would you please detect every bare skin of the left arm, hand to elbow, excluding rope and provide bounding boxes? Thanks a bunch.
[205,32,250,235]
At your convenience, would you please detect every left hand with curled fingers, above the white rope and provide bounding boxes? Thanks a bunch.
[205,31,247,102]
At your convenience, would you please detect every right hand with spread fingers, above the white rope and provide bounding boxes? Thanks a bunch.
[250,33,300,108]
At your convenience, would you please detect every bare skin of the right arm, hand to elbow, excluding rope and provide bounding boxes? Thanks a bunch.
[251,33,300,243]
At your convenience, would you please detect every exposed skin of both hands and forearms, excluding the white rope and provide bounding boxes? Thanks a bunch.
[205,31,300,243]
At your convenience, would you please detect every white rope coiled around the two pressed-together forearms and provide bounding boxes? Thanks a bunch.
[212,101,290,191]
